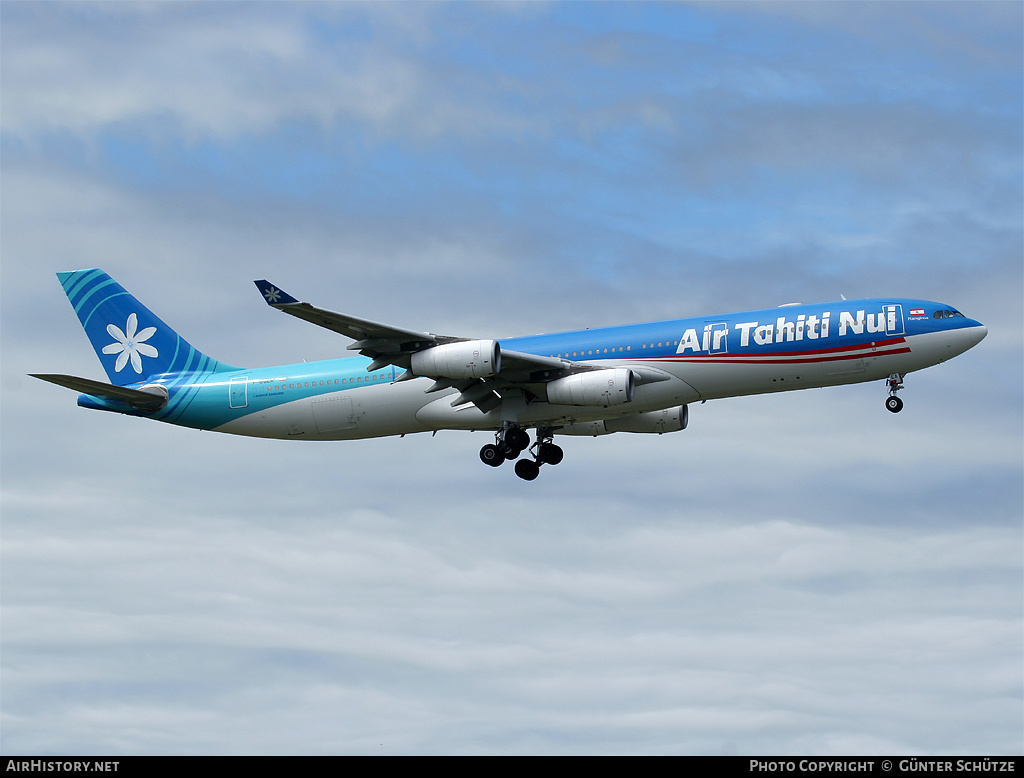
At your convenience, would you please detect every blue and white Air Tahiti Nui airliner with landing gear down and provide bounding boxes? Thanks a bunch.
[32,269,988,481]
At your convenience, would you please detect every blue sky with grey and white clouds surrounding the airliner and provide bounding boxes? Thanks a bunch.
[0,2,1024,754]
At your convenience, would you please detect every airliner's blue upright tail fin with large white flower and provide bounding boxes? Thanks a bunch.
[57,269,238,386]
